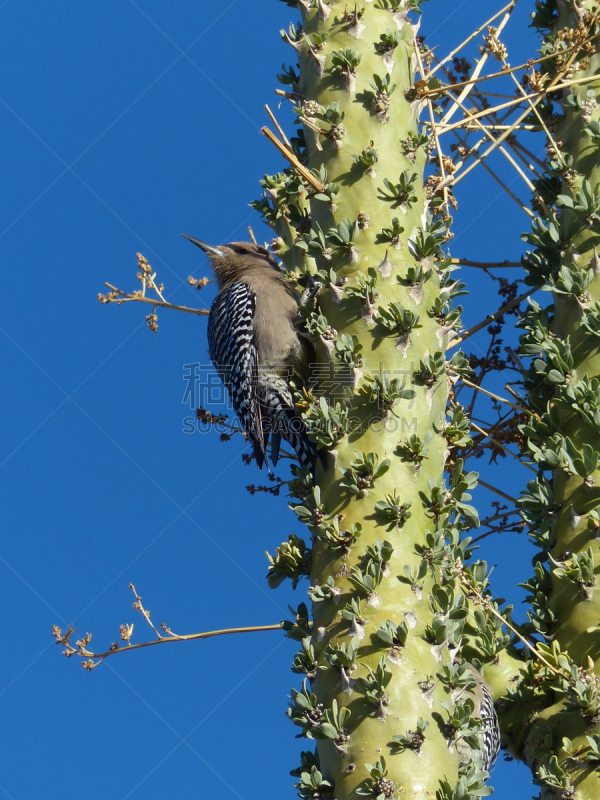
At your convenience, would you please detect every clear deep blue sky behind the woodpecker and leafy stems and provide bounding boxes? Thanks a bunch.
[0,0,541,800]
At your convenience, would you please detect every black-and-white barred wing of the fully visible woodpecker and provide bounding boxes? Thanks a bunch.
[208,281,266,468]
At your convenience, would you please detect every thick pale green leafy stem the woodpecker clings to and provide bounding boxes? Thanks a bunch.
[254,0,500,800]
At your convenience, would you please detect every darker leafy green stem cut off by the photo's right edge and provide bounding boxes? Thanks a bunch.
[508,0,600,788]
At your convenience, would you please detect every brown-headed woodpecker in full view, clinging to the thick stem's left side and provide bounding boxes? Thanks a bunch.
[182,234,317,471]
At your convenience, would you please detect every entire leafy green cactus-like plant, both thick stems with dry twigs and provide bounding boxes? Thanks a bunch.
[92,0,600,800]
